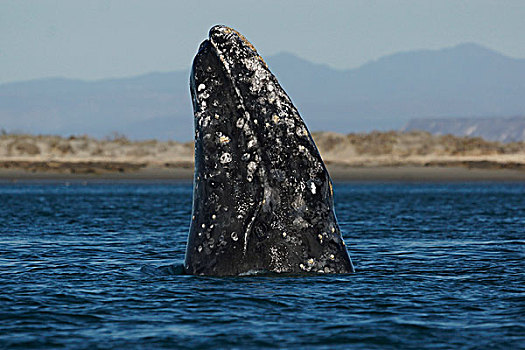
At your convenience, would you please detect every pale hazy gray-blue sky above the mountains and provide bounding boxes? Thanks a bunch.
[0,0,525,83]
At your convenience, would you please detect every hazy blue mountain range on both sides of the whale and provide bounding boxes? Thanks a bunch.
[0,44,525,141]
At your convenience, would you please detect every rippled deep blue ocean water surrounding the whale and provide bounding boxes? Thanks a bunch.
[0,182,525,349]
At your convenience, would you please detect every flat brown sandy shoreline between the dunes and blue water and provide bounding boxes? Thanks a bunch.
[0,164,525,183]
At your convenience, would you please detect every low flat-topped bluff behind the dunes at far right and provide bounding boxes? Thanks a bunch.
[403,116,525,142]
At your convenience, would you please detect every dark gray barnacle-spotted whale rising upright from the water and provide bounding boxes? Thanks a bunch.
[184,26,354,276]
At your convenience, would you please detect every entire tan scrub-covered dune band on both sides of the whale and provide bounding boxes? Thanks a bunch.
[0,131,525,173]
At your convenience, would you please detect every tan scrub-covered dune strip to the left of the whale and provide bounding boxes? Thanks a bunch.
[0,134,193,174]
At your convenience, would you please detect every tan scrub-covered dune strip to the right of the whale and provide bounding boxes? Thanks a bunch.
[312,131,525,166]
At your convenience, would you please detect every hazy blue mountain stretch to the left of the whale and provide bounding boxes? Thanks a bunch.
[0,72,193,140]
